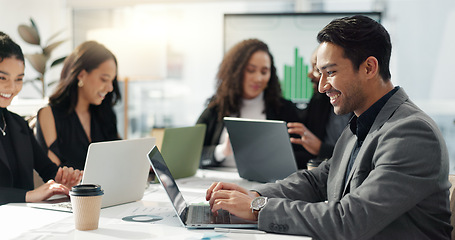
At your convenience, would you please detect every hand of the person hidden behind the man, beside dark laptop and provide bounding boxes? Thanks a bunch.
[287,123,322,156]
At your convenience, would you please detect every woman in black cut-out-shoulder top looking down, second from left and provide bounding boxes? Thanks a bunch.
[36,41,120,169]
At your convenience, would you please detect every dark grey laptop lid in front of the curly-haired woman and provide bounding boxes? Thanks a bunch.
[223,117,297,182]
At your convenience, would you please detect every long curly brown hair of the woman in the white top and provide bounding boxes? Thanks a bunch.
[208,39,282,120]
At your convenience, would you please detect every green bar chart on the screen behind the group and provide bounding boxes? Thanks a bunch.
[281,48,313,102]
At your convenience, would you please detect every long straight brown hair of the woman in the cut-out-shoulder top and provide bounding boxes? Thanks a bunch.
[49,41,121,130]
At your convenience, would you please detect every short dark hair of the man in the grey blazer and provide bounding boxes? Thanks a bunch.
[317,15,392,82]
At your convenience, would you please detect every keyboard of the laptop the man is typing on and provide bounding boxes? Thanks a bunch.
[191,205,231,224]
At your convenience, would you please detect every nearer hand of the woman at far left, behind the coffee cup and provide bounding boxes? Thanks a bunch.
[25,180,69,202]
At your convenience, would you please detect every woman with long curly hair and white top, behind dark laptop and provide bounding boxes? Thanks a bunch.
[197,39,300,167]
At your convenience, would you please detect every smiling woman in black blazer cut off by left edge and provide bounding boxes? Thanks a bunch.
[0,32,82,205]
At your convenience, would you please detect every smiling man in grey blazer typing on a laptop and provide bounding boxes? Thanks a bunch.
[206,16,452,239]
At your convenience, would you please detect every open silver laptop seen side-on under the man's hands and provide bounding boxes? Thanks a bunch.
[148,146,257,228]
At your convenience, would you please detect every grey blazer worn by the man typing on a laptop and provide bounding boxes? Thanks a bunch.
[256,89,452,240]
